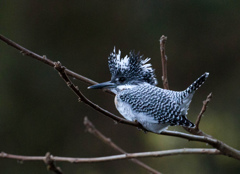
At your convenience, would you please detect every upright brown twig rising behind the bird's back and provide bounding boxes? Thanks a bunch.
[160,35,169,89]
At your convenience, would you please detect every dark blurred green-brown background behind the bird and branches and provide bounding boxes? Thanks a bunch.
[0,0,240,174]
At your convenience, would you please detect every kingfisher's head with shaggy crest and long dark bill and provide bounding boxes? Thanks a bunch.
[88,48,157,92]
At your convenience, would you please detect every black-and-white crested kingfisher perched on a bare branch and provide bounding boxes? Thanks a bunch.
[88,47,209,133]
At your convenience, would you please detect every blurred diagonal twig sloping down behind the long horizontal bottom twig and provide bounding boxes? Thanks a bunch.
[84,117,161,174]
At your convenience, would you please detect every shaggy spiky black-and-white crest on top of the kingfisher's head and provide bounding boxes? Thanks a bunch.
[108,47,157,85]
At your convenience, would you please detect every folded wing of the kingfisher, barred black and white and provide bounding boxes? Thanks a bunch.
[118,85,181,125]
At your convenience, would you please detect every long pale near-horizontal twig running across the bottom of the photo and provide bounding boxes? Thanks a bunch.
[0,148,222,163]
